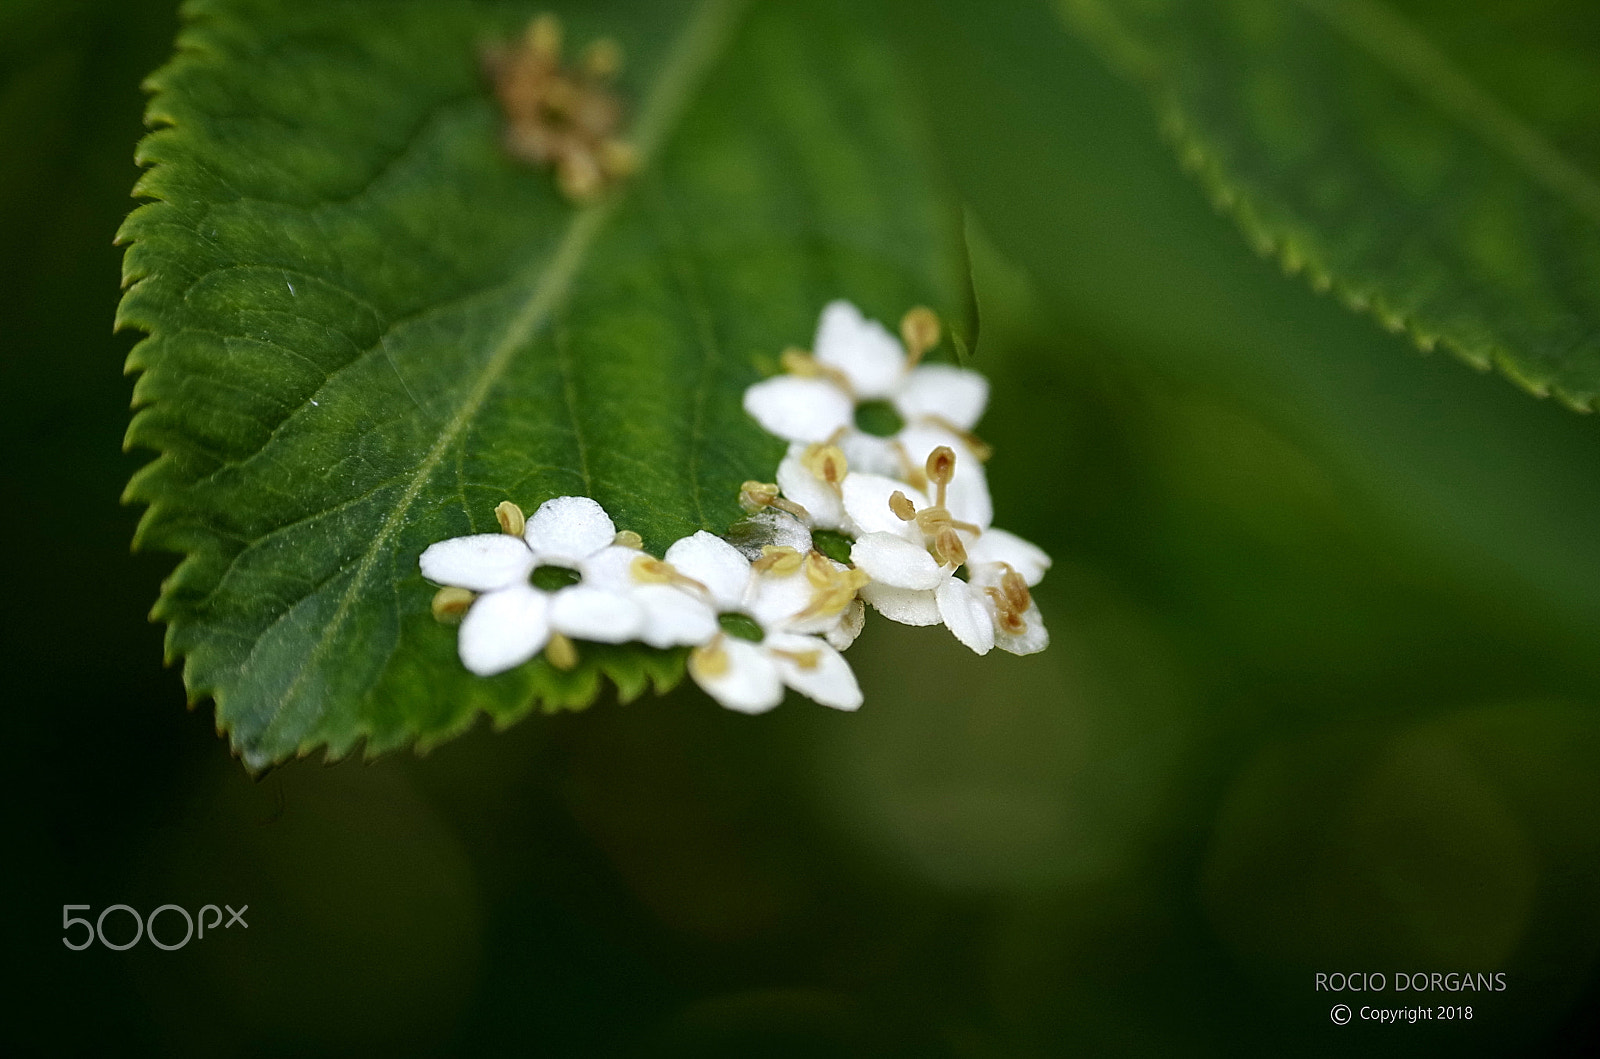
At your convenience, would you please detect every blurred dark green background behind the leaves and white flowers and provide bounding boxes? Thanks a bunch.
[9,0,1600,1056]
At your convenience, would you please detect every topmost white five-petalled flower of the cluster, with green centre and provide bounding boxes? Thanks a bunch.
[744,301,994,528]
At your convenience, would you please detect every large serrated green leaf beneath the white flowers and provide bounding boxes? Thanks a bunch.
[118,0,965,768]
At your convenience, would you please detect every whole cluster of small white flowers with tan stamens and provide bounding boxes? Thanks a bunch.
[421,301,1050,713]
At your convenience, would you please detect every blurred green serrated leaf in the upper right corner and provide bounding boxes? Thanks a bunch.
[1058,0,1600,410]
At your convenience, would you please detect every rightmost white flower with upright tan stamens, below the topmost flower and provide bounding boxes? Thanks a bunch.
[843,450,1050,654]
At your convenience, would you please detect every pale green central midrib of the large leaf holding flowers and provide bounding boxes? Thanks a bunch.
[259,0,746,751]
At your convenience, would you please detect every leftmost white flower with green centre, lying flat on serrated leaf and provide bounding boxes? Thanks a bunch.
[419,496,648,677]
